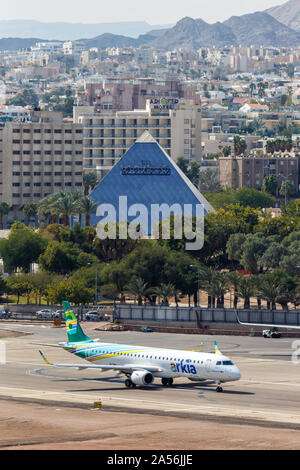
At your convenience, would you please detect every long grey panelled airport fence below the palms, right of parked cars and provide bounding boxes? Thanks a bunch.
[116,305,300,326]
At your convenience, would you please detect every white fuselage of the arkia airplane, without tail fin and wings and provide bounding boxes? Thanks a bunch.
[64,342,241,383]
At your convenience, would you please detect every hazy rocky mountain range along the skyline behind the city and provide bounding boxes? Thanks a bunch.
[0,8,300,50]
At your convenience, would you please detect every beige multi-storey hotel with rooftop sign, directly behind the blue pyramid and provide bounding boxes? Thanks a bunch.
[74,98,201,178]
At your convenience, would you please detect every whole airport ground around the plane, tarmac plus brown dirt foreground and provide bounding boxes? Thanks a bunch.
[0,322,300,449]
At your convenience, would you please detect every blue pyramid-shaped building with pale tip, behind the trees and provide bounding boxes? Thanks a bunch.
[90,131,214,236]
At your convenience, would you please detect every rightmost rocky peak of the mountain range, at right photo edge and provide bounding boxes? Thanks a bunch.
[224,12,300,47]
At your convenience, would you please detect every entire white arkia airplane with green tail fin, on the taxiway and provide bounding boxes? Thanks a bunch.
[39,301,241,392]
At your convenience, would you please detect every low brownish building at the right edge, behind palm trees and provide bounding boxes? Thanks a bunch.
[219,154,300,192]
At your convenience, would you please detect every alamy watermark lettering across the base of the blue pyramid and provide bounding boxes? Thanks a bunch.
[96,195,204,251]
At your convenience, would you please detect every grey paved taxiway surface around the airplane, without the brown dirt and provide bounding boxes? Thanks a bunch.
[0,322,300,430]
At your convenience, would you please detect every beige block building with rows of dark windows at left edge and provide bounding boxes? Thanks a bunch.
[0,111,83,217]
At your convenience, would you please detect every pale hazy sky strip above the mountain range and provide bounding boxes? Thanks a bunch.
[0,0,286,24]
